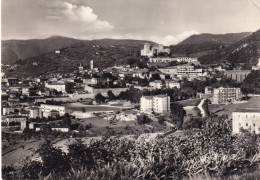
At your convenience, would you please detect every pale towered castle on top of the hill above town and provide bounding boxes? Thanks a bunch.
[141,43,170,57]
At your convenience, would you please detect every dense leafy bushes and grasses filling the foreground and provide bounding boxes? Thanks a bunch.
[3,116,260,179]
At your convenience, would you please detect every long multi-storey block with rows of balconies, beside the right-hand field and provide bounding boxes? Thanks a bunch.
[212,87,242,104]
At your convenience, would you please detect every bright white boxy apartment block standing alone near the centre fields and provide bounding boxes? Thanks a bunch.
[140,95,170,114]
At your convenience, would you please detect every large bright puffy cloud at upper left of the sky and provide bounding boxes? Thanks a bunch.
[46,1,114,32]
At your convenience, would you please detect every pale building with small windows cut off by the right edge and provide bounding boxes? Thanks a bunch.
[232,109,260,134]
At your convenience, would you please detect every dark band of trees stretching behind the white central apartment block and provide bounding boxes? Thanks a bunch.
[95,75,249,103]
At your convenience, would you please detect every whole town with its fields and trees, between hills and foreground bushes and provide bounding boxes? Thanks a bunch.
[1,43,260,173]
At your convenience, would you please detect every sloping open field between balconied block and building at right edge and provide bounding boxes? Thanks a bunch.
[209,97,260,118]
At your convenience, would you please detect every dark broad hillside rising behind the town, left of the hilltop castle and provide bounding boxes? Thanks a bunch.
[6,39,155,77]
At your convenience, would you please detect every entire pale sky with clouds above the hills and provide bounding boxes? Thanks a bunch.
[1,0,260,45]
